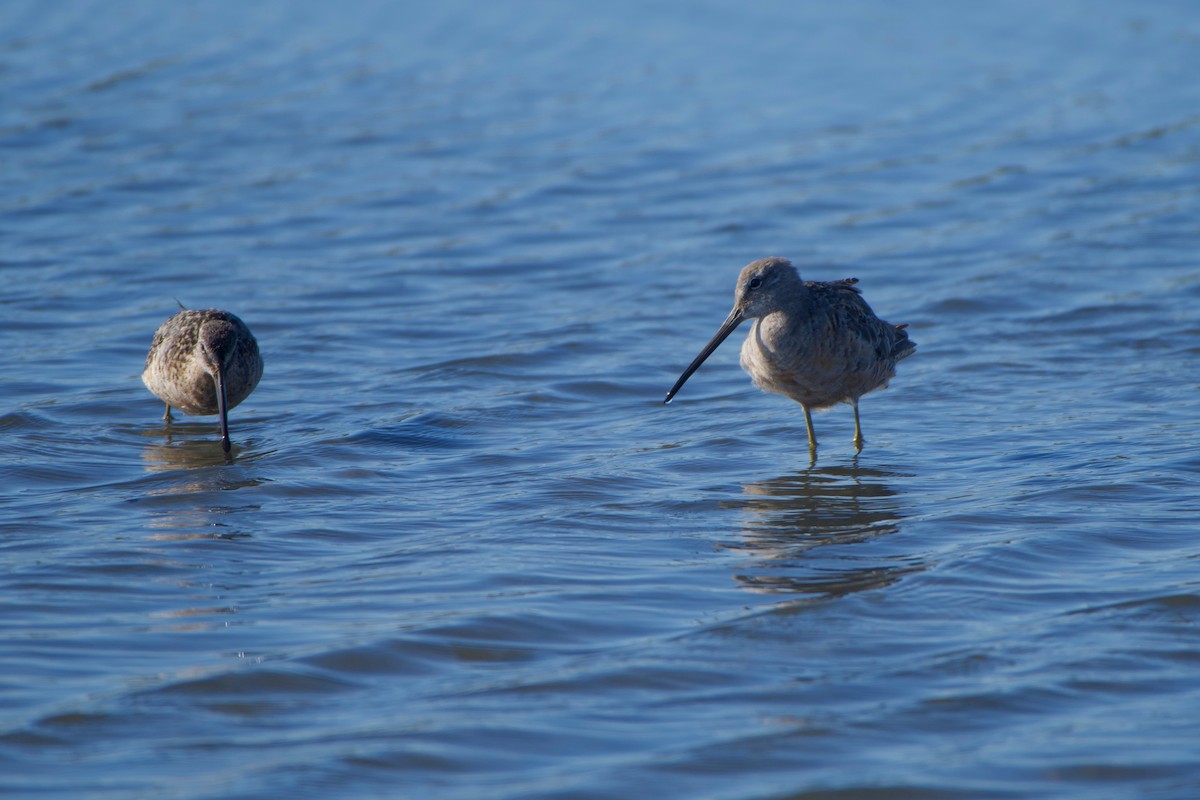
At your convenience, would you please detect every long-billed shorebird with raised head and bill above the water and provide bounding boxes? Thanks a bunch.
[664,258,917,452]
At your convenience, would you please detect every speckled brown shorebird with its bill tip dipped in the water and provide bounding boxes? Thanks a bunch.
[142,308,263,452]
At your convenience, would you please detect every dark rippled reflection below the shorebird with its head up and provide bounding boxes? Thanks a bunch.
[727,464,920,597]
